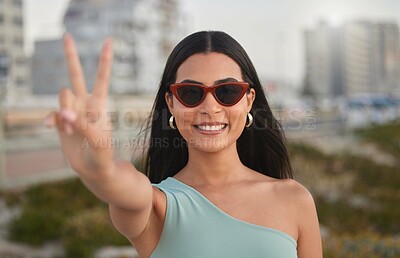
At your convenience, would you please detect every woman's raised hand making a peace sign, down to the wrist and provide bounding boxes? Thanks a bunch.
[45,34,112,175]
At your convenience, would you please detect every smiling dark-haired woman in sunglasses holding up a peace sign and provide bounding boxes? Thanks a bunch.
[47,31,322,258]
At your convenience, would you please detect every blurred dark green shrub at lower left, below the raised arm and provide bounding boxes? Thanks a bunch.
[9,178,129,257]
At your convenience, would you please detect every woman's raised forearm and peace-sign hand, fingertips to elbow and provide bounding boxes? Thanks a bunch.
[46,35,153,236]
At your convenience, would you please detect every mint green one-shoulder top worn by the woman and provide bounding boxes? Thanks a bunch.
[151,177,297,258]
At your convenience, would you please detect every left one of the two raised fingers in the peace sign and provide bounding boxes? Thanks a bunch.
[64,33,87,97]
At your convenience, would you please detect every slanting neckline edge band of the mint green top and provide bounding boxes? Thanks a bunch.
[166,177,297,246]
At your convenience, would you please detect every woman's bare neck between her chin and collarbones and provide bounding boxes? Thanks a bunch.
[180,144,247,186]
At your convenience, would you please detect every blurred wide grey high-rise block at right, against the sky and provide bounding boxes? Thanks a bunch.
[304,21,400,98]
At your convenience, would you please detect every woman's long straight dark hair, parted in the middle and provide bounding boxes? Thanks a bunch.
[139,31,293,183]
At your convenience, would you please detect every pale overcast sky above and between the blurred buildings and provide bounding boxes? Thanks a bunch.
[24,0,400,84]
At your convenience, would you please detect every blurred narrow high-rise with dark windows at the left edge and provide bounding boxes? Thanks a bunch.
[0,0,30,102]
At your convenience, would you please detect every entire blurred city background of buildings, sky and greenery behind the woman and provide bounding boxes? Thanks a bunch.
[0,0,400,258]
